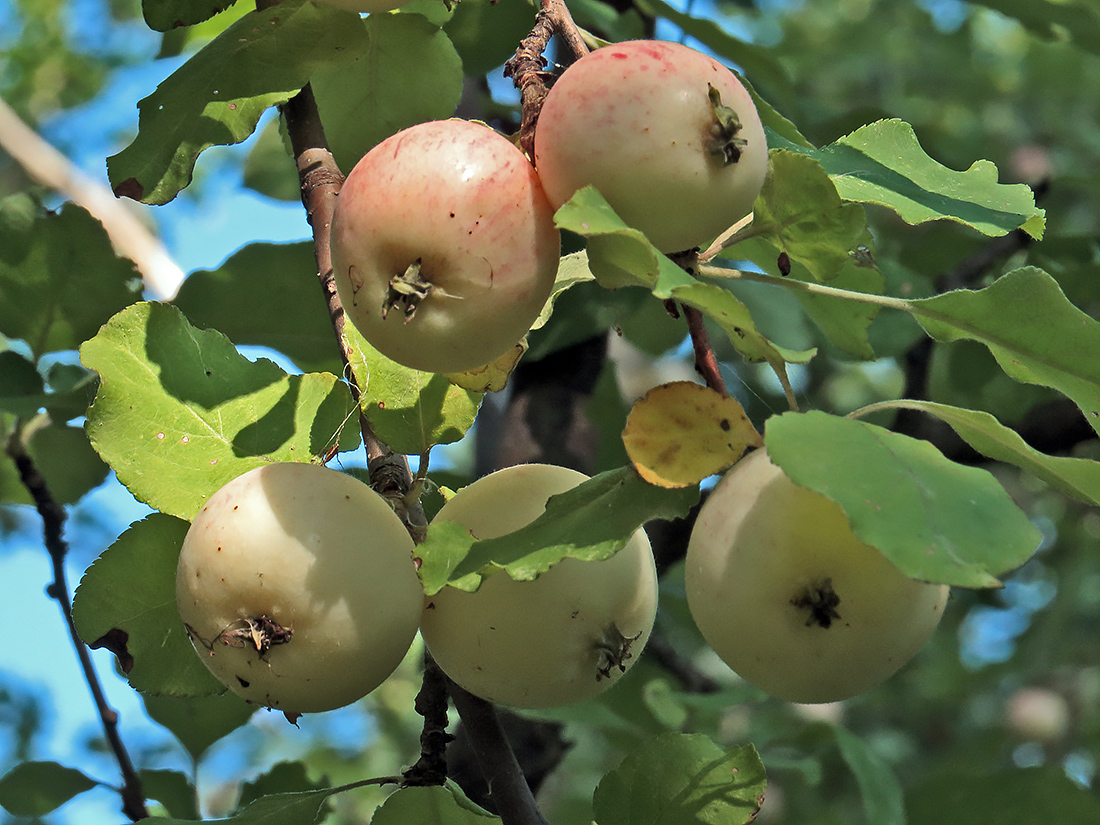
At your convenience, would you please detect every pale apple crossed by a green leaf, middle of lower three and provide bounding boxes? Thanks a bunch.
[420,464,657,708]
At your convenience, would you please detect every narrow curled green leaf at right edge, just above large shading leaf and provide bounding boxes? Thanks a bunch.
[866,398,1100,506]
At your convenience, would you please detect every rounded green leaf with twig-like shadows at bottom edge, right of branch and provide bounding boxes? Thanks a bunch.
[592,734,766,825]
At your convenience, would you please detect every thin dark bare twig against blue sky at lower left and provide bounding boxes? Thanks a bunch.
[6,427,149,822]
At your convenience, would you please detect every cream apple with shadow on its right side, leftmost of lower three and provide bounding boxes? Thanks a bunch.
[176,463,424,714]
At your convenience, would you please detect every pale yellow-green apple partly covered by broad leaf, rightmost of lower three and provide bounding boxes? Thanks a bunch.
[685,450,948,704]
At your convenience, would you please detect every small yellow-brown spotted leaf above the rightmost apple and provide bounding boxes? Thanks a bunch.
[623,381,761,487]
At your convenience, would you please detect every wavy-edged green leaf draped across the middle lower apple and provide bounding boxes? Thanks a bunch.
[417,468,699,595]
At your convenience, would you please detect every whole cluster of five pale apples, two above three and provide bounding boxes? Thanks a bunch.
[176,41,947,714]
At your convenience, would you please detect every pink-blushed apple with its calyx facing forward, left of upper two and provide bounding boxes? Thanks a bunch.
[331,120,561,373]
